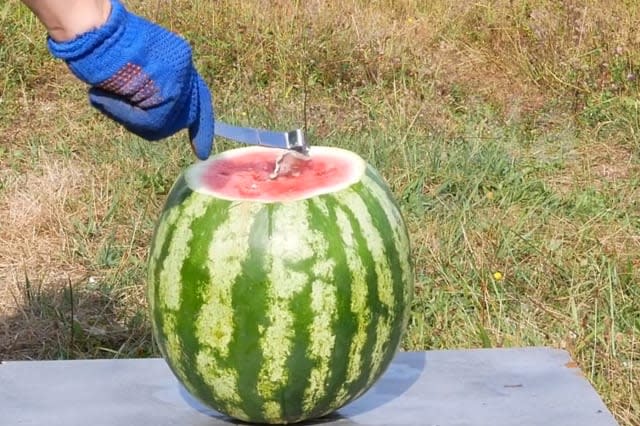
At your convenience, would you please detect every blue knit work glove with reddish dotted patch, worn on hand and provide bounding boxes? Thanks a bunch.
[47,0,214,160]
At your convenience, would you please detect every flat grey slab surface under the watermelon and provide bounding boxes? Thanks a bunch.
[0,348,617,426]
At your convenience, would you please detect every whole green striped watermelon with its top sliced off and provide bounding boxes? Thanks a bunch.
[147,146,413,423]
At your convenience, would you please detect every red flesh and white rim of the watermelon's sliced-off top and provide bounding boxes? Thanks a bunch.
[185,146,366,202]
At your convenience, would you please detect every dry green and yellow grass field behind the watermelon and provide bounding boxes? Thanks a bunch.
[0,0,640,425]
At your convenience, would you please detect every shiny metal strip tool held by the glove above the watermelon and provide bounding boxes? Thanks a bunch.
[215,121,309,156]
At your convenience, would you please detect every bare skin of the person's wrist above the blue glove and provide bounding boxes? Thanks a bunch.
[22,0,111,41]
